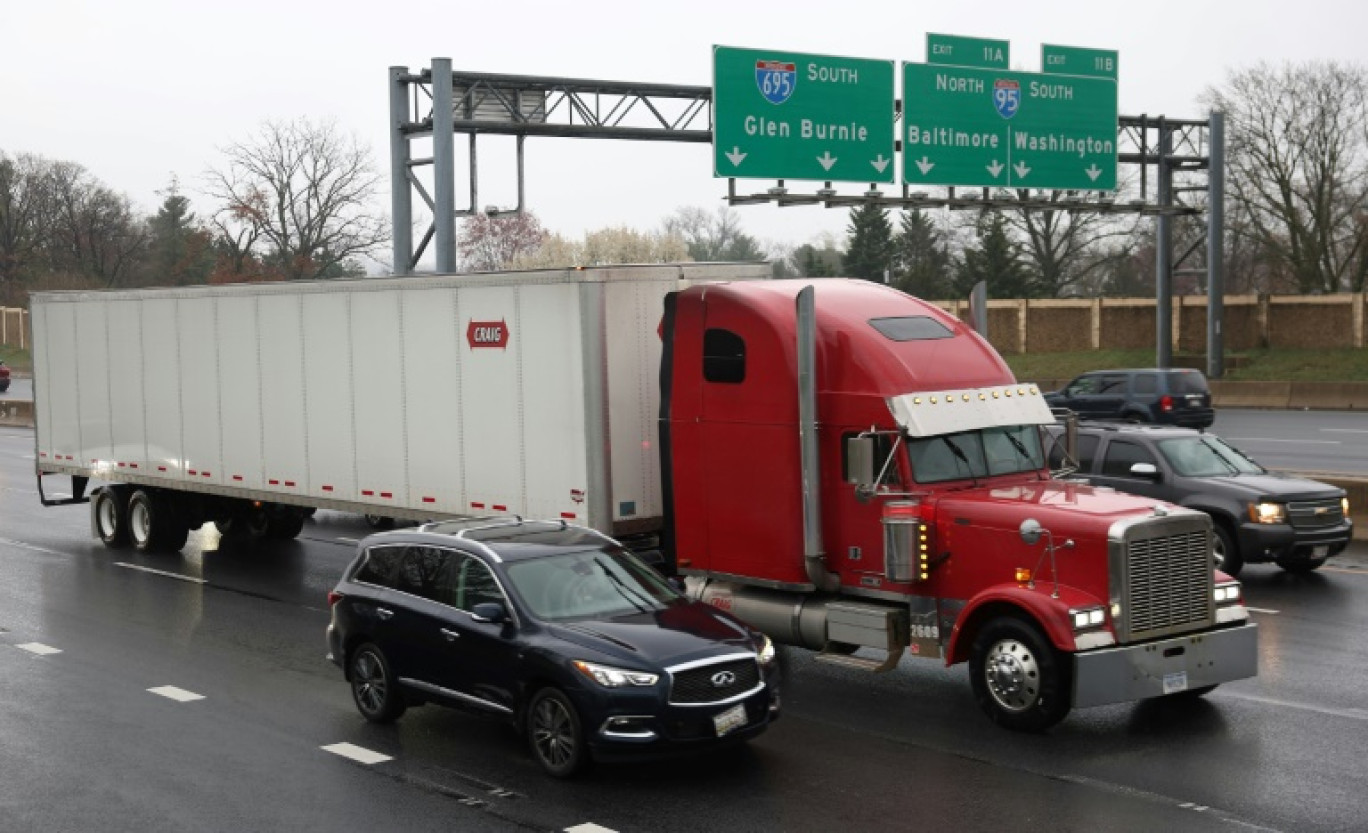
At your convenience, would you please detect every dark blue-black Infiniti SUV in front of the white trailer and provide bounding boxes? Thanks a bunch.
[327,520,780,777]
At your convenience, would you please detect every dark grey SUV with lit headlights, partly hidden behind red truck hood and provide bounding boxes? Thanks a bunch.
[1049,423,1353,576]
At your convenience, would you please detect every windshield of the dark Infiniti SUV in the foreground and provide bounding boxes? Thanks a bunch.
[506,548,684,622]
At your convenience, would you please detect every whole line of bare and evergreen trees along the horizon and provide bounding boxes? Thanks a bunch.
[0,62,1368,305]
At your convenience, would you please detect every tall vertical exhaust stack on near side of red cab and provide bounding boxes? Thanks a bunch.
[798,285,841,592]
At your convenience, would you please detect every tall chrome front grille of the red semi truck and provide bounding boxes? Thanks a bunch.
[1118,516,1215,642]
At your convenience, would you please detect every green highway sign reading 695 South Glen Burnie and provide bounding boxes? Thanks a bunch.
[713,47,895,182]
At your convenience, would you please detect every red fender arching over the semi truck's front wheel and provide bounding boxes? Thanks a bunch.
[945,581,1105,665]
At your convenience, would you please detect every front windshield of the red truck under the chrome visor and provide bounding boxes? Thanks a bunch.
[907,425,1045,483]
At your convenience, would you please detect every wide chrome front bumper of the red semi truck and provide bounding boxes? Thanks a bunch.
[1074,622,1259,709]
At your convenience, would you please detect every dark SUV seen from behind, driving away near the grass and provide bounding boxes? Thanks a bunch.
[1045,368,1216,428]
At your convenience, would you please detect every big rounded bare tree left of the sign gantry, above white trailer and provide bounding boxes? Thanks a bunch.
[207,119,390,279]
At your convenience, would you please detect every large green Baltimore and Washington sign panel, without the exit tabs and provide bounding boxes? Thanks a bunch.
[902,63,1116,190]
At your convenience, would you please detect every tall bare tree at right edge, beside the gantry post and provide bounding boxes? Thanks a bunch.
[1202,62,1368,293]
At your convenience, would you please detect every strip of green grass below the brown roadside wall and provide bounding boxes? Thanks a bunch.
[1003,347,1368,382]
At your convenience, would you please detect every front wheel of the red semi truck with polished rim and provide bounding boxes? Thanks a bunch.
[970,617,1071,732]
